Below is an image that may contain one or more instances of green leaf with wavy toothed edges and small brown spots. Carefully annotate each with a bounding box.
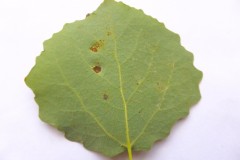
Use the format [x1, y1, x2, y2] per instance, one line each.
[26, 0, 202, 160]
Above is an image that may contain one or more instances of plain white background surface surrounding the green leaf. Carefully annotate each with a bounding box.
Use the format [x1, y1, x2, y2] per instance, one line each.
[0, 0, 240, 160]
